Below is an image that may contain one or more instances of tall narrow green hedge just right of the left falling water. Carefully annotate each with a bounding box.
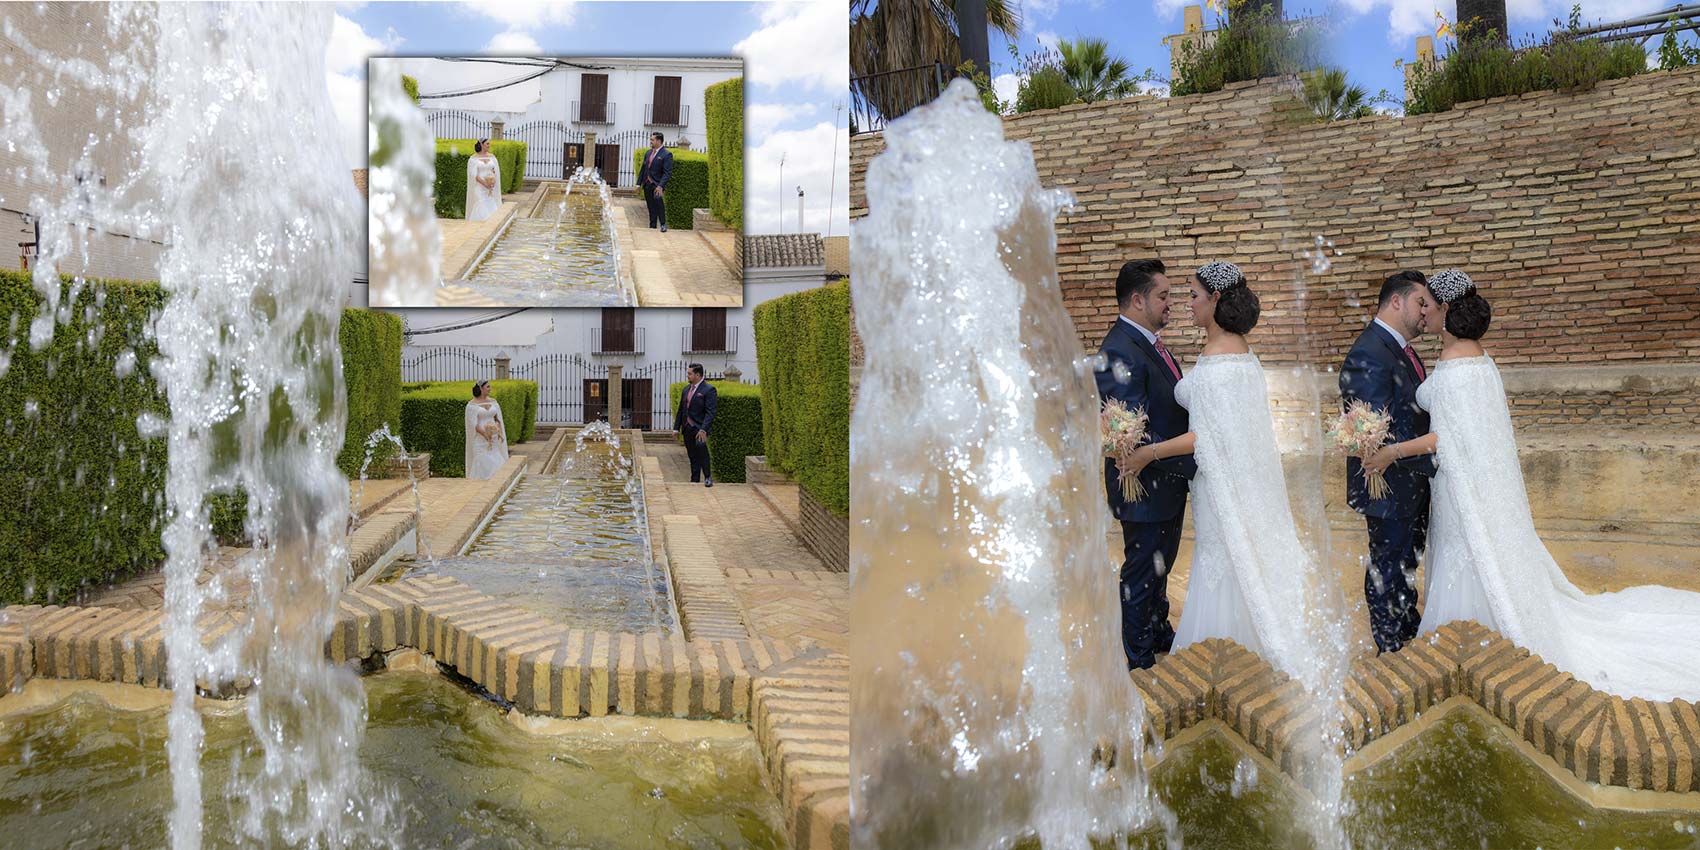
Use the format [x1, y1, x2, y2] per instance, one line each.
[337, 308, 401, 479]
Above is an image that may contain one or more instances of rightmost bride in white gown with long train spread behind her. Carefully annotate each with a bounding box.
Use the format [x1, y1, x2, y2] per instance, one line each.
[1365, 270, 1700, 700]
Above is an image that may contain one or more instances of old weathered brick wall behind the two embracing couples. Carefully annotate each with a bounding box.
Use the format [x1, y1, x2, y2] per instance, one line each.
[850, 68, 1700, 379]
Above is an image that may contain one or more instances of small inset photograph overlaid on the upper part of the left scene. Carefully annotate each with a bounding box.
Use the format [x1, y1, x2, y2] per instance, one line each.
[369, 56, 745, 308]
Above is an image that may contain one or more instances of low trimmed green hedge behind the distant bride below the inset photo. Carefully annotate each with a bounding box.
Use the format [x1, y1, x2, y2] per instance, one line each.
[401, 381, 537, 478]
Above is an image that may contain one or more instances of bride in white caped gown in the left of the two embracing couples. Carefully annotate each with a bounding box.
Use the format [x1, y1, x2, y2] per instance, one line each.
[1124, 262, 1331, 682]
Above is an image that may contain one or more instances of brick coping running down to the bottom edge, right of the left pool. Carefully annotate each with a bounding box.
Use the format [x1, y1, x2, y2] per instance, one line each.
[750, 651, 850, 850]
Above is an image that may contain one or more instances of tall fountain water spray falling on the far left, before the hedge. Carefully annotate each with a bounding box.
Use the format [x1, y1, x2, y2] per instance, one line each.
[0, 3, 397, 850]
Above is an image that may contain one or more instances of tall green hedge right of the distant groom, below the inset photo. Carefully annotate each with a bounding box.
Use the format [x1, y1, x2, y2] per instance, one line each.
[755, 282, 850, 517]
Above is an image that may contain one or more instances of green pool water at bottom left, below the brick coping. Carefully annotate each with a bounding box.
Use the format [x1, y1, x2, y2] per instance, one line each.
[0, 673, 785, 850]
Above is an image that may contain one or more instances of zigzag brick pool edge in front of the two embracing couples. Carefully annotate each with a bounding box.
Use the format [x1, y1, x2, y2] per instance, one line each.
[1132, 622, 1700, 792]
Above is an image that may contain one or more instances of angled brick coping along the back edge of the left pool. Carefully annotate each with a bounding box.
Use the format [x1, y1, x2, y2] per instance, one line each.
[0, 576, 796, 721]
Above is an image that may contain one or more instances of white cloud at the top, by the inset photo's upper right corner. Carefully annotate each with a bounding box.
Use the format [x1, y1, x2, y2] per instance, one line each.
[733, 3, 850, 92]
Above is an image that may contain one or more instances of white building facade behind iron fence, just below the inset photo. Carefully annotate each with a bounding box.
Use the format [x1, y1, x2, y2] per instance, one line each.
[394, 233, 828, 430]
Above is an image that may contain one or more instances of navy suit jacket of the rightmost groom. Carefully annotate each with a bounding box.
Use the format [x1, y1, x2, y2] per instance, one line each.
[1340, 321, 1435, 520]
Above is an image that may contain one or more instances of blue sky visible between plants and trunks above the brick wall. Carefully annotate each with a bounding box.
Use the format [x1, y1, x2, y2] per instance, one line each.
[991, 0, 1693, 111]
